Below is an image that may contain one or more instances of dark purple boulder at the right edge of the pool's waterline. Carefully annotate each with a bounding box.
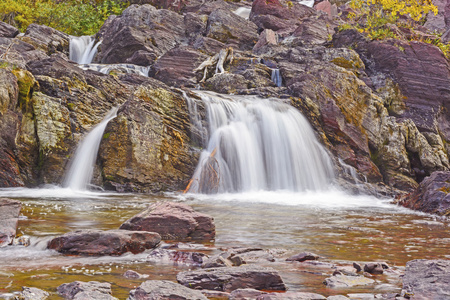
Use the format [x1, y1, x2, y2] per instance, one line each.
[399, 171, 450, 216]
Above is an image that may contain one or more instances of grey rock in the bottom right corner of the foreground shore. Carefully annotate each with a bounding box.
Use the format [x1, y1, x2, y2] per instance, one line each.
[403, 259, 450, 299]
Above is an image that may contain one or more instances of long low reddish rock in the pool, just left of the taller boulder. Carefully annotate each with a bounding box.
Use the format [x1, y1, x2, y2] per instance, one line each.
[48, 229, 161, 255]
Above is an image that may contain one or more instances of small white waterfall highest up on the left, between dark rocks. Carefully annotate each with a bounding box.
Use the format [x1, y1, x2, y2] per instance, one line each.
[69, 36, 101, 64]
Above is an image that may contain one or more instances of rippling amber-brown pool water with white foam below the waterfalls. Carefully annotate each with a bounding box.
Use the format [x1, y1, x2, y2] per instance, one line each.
[0, 190, 450, 299]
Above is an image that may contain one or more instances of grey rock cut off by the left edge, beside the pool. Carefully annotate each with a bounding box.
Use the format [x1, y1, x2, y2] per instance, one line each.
[0, 198, 22, 248]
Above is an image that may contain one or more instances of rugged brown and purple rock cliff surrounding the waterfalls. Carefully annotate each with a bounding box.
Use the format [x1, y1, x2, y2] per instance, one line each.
[0, 0, 450, 194]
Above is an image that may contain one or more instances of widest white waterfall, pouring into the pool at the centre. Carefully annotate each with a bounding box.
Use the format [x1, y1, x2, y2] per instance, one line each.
[188, 92, 334, 193]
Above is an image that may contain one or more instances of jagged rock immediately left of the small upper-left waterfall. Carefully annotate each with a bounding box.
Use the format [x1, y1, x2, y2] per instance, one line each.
[20, 23, 70, 57]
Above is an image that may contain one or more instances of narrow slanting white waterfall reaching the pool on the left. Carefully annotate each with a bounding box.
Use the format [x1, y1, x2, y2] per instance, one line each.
[63, 107, 118, 191]
